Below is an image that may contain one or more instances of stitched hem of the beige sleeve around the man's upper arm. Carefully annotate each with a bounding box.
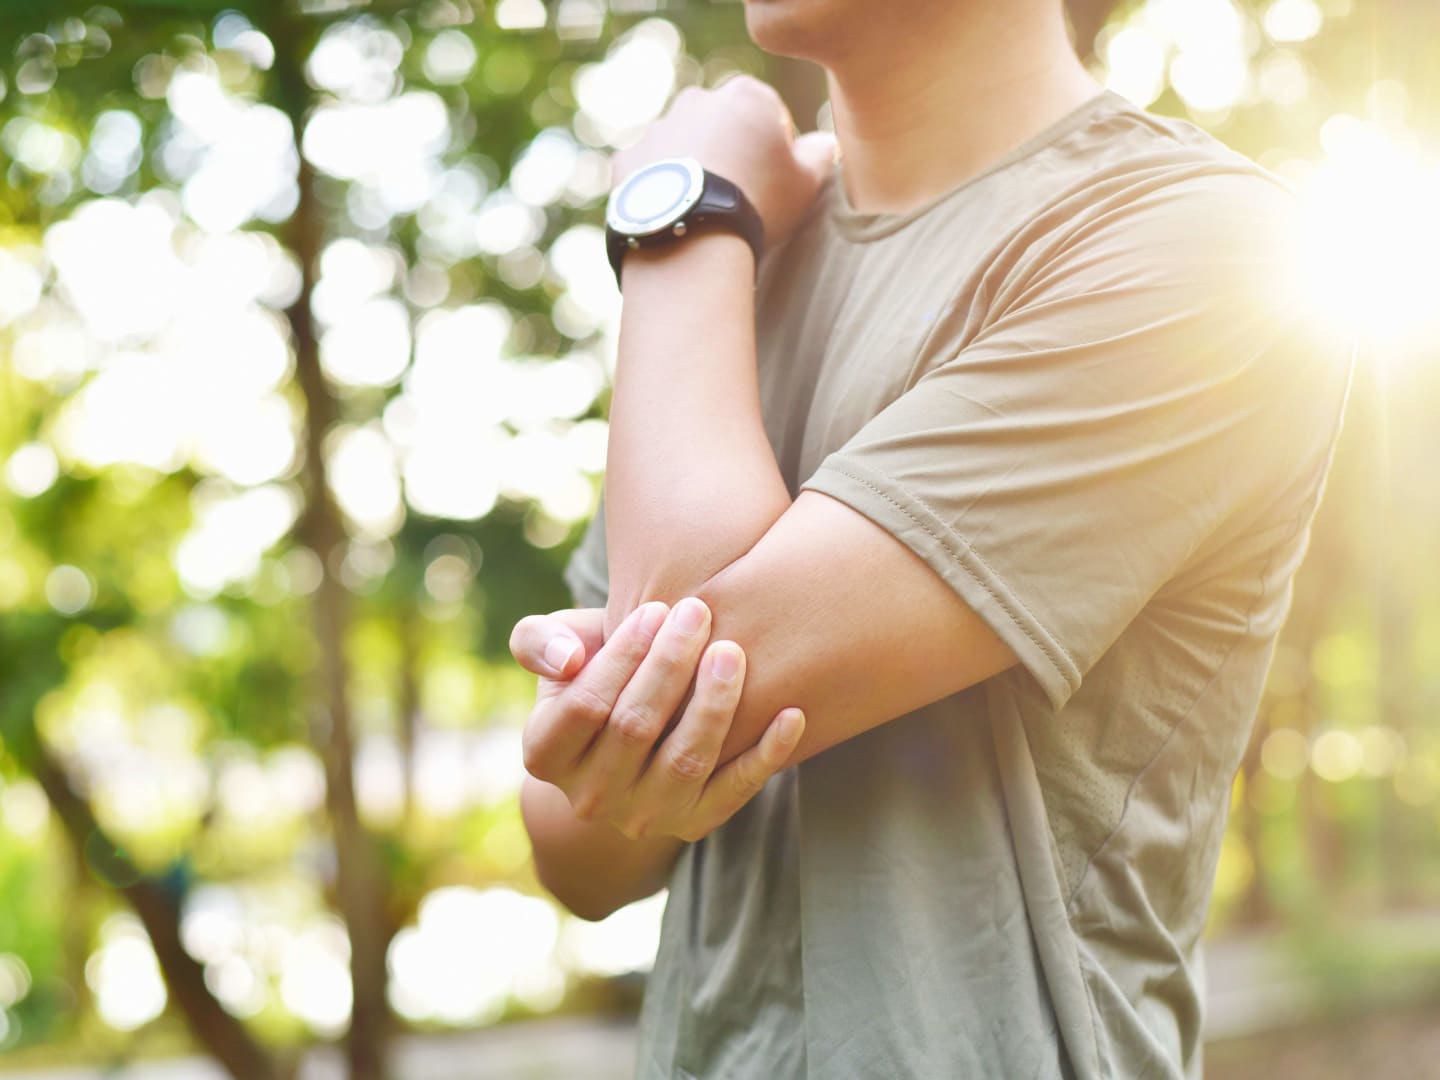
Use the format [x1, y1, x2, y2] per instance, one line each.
[801, 455, 1080, 711]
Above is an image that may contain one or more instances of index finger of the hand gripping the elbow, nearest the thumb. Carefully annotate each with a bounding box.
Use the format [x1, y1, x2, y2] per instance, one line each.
[521, 600, 668, 793]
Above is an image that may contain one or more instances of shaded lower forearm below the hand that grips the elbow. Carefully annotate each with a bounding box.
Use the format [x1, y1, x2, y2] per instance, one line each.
[520, 776, 683, 919]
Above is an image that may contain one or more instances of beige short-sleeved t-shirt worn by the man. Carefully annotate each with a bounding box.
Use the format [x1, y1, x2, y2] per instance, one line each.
[558, 94, 1349, 1080]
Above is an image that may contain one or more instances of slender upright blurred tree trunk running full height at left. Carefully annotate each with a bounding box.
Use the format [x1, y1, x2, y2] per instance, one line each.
[269, 16, 393, 1080]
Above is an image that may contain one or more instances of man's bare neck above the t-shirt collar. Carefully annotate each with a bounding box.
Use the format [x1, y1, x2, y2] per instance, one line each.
[828, 4, 1100, 213]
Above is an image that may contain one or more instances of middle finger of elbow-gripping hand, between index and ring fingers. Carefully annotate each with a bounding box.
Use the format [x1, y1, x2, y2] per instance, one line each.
[567, 596, 710, 805]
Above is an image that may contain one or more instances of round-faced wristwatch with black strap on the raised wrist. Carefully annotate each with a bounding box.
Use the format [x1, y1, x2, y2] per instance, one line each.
[605, 157, 765, 284]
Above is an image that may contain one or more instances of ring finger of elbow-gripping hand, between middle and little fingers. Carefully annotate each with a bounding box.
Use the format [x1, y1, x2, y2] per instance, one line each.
[638, 641, 744, 805]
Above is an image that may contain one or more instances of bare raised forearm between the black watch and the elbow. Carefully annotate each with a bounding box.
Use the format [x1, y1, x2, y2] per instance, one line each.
[605, 233, 791, 628]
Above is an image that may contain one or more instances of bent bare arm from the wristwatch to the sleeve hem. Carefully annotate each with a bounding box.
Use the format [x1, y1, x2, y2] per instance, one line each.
[606, 236, 1015, 762]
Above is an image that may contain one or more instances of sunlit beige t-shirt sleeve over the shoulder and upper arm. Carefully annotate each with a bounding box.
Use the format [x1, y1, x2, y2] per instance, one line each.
[802, 174, 1349, 710]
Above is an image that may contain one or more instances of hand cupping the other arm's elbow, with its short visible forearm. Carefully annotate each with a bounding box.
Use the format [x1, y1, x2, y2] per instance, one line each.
[510, 610, 805, 919]
